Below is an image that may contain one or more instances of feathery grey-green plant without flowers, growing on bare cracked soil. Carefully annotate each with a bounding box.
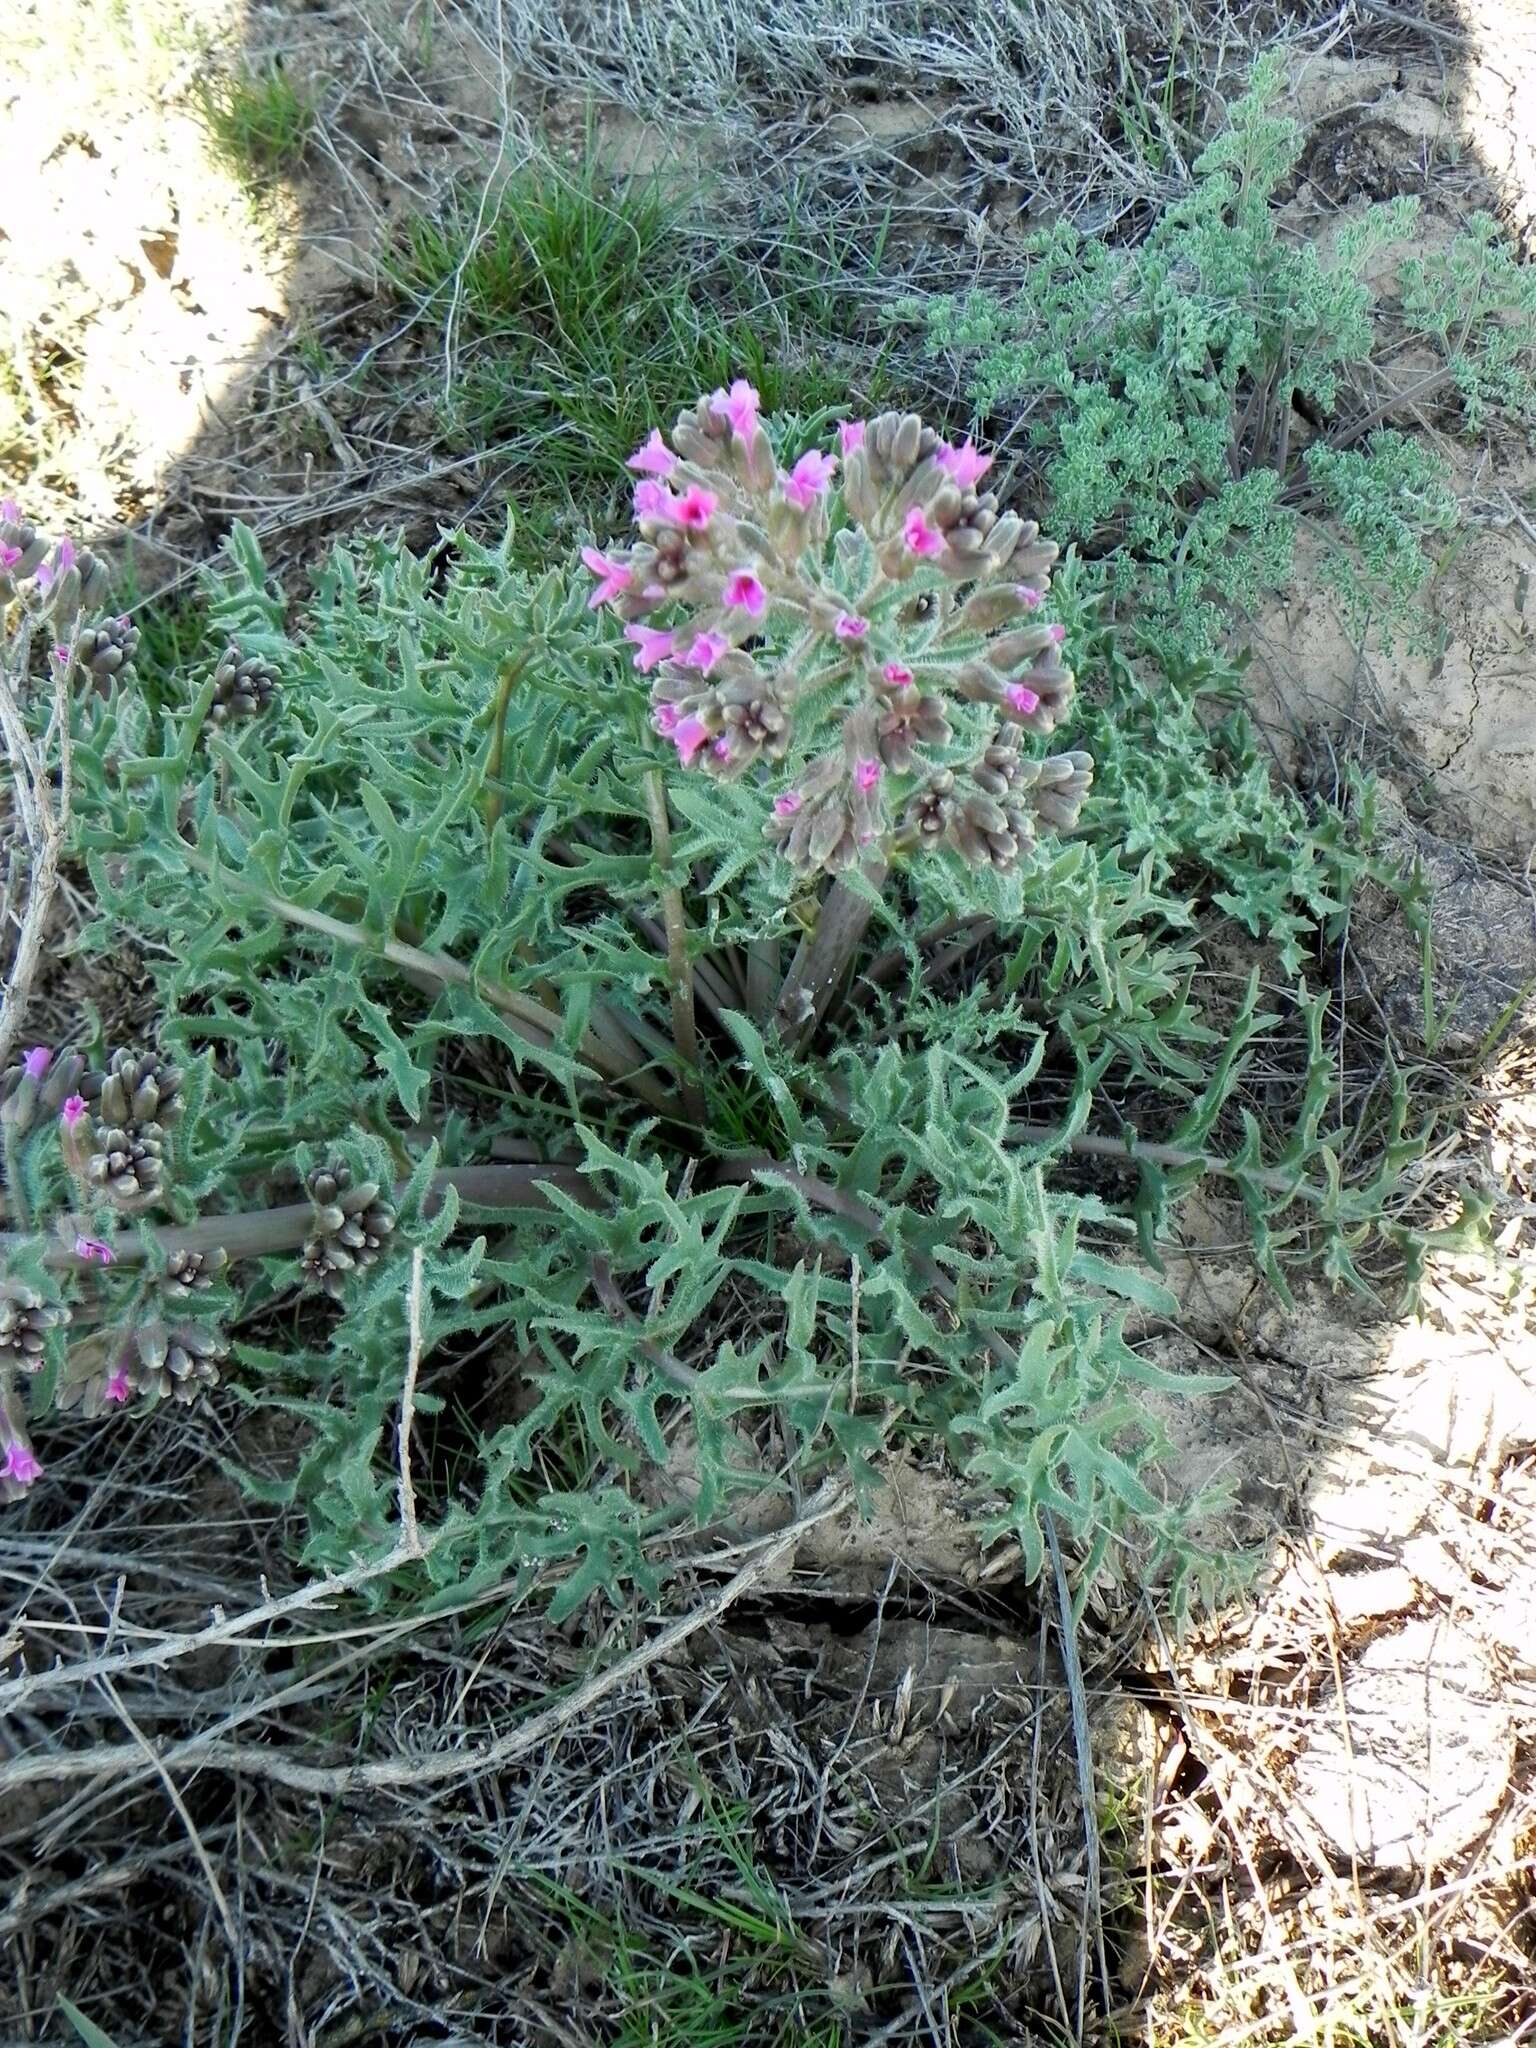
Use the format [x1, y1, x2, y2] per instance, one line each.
[907, 59, 1536, 659]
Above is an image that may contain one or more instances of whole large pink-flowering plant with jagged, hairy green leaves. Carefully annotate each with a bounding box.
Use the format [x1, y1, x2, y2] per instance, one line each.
[0, 399, 1490, 1612]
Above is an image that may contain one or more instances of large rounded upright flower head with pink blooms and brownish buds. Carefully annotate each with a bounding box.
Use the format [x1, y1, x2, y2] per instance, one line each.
[582, 379, 1094, 874]
